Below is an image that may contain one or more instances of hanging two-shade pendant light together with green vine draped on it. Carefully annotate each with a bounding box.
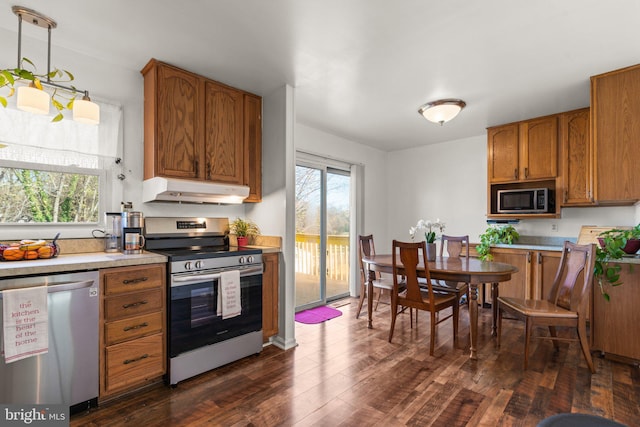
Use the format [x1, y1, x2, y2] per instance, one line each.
[0, 6, 100, 124]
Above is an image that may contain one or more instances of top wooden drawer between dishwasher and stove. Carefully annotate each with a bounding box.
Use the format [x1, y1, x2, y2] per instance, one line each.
[104, 265, 164, 295]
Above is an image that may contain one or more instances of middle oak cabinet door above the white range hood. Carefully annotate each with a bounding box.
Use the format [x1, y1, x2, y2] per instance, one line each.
[204, 81, 244, 185]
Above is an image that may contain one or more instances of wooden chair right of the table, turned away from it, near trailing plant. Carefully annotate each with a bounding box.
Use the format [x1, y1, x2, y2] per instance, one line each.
[497, 241, 596, 373]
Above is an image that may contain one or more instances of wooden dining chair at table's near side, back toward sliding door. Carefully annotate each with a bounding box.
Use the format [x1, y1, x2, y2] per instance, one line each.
[389, 240, 460, 356]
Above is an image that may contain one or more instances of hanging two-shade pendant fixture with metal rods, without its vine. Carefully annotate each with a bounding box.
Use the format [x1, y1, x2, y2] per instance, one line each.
[11, 6, 100, 124]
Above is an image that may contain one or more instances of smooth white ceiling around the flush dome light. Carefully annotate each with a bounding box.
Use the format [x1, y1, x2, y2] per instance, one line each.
[0, 0, 640, 151]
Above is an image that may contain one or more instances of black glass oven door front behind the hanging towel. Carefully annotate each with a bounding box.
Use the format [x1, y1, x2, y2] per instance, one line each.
[169, 274, 262, 357]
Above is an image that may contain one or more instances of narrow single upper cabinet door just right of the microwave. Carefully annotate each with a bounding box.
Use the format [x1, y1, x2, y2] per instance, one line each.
[557, 108, 594, 206]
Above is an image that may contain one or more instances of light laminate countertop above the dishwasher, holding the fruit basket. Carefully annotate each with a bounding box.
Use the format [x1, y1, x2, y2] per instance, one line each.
[0, 252, 167, 278]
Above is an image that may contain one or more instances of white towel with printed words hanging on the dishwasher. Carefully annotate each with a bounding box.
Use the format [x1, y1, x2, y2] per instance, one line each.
[2, 286, 49, 363]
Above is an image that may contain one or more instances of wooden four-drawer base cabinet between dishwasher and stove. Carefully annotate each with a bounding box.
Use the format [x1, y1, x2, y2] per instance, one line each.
[100, 264, 166, 400]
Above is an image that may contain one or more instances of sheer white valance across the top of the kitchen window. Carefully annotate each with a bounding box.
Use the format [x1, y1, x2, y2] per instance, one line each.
[0, 100, 122, 158]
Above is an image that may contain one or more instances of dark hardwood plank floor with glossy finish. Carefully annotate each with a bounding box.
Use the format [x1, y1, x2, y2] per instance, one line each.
[71, 299, 640, 427]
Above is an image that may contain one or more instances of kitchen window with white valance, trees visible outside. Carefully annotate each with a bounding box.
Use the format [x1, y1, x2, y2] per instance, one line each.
[0, 103, 124, 239]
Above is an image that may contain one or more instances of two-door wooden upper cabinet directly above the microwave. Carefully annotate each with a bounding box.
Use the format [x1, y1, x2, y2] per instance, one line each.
[487, 116, 558, 183]
